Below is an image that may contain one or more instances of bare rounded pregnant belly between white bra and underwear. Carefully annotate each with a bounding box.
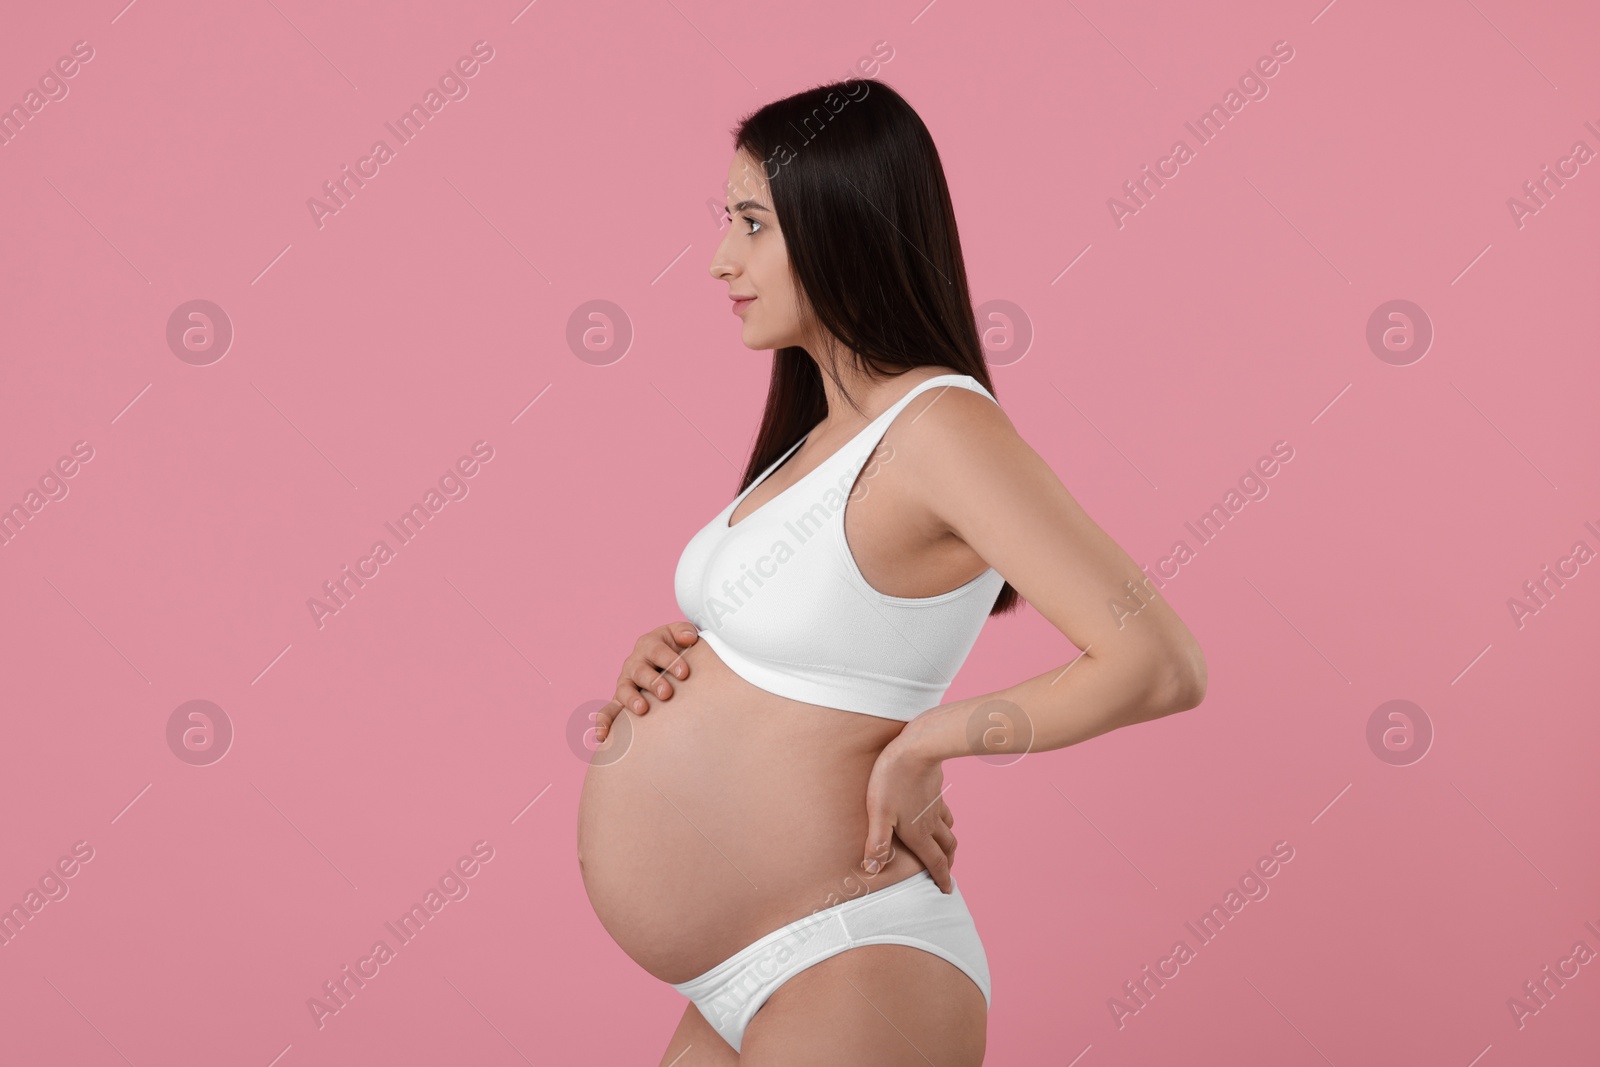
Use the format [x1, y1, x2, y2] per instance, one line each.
[578, 641, 923, 982]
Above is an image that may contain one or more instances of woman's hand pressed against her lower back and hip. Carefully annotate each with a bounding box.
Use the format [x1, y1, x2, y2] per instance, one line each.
[861, 741, 955, 893]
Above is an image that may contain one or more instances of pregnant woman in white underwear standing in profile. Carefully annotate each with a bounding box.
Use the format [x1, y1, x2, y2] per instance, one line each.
[578, 78, 1205, 1067]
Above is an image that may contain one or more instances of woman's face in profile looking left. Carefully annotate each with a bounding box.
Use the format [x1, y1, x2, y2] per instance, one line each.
[710, 152, 810, 350]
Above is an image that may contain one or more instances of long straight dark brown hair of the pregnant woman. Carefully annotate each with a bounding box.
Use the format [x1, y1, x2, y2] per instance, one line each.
[733, 78, 1019, 614]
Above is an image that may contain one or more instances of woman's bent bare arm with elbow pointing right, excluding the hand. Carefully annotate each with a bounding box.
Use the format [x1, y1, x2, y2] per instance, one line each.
[896, 389, 1206, 760]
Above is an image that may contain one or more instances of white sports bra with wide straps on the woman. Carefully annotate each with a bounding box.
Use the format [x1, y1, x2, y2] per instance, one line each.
[674, 374, 1005, 721]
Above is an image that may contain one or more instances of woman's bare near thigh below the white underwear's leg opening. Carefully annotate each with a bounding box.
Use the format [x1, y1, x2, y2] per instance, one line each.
[739, 945, 989, 1067]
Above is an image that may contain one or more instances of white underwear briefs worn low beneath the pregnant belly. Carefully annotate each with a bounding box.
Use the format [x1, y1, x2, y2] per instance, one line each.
[672, 870, 990, 1051]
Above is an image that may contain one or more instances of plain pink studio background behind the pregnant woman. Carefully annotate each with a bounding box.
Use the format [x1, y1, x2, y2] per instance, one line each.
[0, 0, 1600, 1067]
